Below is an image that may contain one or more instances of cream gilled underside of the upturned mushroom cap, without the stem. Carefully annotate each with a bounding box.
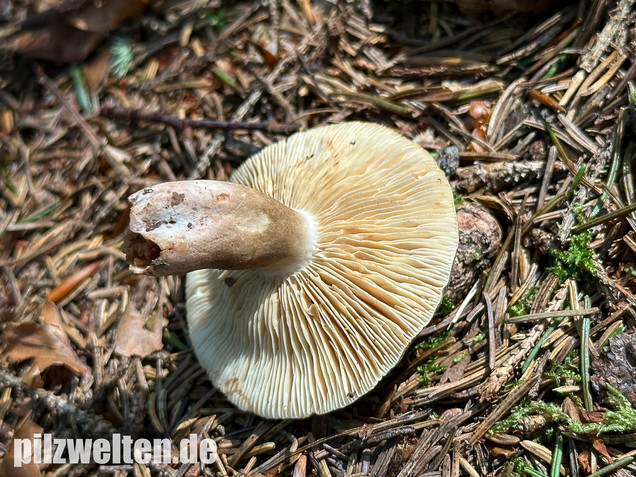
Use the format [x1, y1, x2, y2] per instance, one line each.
[186, 122, 458, 418]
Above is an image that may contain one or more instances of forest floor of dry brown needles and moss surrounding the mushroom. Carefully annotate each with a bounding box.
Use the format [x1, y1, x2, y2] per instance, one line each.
[0, 0, 636, 477]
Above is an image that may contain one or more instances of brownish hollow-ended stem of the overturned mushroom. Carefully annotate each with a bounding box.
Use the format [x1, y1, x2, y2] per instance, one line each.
[123, 180, 316, 276]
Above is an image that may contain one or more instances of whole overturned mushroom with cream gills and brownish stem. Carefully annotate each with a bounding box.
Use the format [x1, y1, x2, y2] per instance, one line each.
[124, 122, 458, 418]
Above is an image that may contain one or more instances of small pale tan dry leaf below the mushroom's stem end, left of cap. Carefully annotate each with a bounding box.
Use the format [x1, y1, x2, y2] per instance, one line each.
[115, 304, 166, 357]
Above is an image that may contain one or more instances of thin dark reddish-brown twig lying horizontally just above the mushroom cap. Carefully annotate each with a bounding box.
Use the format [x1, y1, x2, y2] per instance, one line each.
[99, 107, 298, 133]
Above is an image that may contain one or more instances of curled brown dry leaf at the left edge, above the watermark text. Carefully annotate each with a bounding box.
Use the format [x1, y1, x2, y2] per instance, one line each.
[2, 301, 89, 387]
